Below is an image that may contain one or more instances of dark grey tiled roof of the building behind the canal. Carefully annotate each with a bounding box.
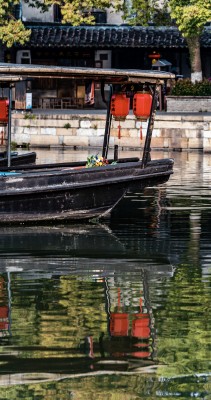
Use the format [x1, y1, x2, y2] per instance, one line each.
[26, 24, 211, 48]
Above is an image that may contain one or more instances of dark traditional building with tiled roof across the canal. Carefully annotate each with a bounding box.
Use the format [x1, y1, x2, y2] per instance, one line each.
[1, 1, 211, 107]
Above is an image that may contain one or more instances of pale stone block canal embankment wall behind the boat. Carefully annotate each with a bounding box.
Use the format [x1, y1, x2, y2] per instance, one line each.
[12, 110, 211, 152]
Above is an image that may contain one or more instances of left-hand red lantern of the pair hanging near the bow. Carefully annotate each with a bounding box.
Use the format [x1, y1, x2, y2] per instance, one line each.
[111, 93, 130, 121]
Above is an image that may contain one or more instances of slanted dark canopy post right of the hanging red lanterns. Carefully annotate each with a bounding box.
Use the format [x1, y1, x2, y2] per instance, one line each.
[142, 84, 159, 168]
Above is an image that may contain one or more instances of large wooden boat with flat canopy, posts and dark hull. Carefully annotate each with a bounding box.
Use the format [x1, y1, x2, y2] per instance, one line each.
[0, 64, 174, 224]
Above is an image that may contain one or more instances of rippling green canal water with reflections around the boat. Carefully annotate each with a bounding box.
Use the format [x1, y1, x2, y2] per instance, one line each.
[0, 150, 211, 400]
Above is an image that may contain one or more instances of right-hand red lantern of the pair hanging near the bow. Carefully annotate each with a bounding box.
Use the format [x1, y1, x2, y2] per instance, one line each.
[133, 93, 152, 121]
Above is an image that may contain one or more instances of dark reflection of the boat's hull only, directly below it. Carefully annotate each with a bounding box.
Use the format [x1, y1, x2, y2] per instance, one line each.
[0, 224, 173, 276]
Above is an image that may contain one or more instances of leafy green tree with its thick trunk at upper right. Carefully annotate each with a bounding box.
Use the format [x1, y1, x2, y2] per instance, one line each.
[120, 0, 211, 82]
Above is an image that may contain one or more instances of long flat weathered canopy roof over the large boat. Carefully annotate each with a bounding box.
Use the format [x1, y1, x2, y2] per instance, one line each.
[0, 63, 175, 84]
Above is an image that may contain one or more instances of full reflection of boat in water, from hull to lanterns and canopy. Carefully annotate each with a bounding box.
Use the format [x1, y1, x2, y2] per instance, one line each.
[0, 212, 178, 380]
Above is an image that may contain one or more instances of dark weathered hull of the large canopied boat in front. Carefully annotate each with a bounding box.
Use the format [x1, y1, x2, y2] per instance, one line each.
[0, 162, 173, 224]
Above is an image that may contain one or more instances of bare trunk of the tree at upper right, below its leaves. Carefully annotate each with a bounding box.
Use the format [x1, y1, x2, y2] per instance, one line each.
[187, 35, 202, 83]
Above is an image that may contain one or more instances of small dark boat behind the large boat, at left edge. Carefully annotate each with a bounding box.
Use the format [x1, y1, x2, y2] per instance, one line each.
[0, 151, 36, 168]
